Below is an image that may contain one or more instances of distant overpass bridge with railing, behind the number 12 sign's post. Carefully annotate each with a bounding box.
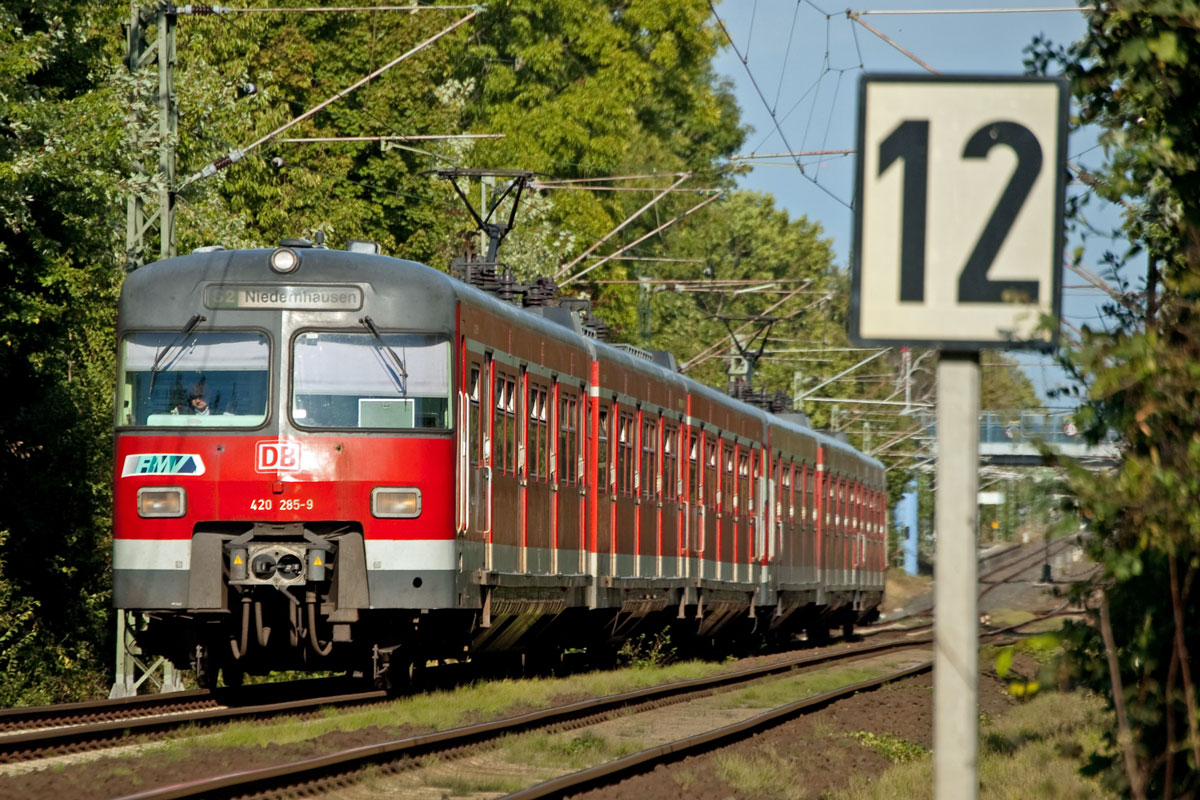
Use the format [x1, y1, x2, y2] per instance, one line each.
[926, 409, 1121, 468]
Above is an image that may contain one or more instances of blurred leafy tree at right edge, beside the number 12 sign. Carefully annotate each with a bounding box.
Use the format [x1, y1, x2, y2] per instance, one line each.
[1031, 0, 1200, 798]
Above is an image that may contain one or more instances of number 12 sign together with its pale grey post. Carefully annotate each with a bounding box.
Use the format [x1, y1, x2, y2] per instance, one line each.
[850, 74, 1067, 800]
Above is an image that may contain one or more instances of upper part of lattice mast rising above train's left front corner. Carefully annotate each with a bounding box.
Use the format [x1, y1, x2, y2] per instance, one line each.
[125, 2, 179, 270]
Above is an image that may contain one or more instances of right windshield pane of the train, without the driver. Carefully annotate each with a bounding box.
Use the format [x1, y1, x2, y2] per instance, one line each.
[292, 331, 450, 429]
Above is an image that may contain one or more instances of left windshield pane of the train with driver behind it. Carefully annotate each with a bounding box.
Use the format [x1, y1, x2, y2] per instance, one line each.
[116, 331, 271, 428]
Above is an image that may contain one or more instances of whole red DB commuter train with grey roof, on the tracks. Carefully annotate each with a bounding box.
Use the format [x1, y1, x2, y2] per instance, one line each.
[113, 240, 886, 685]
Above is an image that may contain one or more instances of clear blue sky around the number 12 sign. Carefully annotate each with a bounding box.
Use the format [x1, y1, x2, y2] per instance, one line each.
[716, 0, 1118, 404]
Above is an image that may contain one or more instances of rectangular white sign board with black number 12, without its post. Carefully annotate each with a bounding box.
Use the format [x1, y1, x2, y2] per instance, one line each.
[850, 74, 1067, 350]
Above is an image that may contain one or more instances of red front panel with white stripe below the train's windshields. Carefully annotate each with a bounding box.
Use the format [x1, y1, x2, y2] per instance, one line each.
[114, 433, 456, 609]
